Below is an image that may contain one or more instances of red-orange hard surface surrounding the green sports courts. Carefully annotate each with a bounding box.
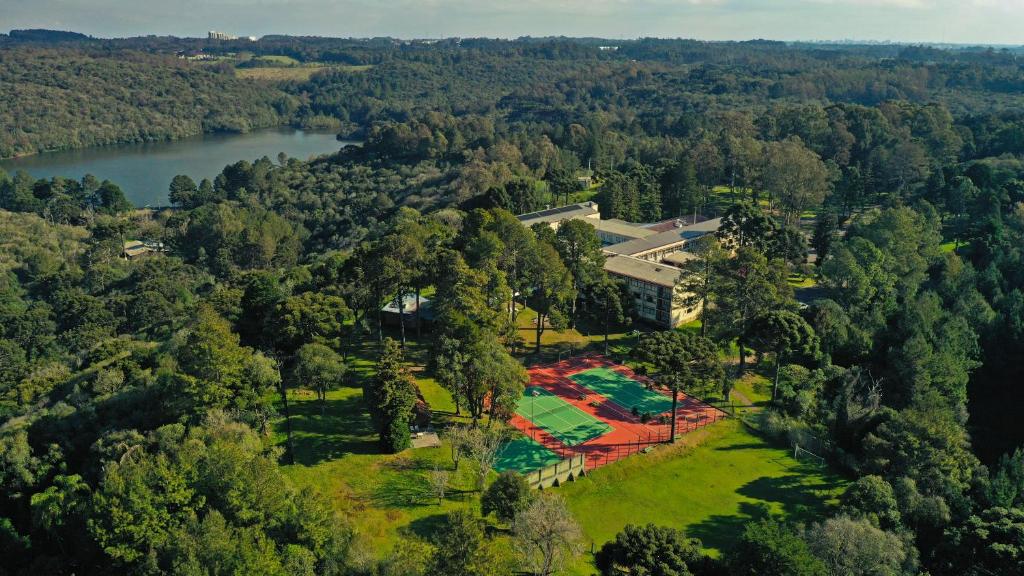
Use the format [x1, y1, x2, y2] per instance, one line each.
[510, 355, 726, 469]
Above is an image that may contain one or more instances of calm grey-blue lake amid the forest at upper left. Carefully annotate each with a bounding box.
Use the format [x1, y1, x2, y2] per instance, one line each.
[0, 128, 359, 207]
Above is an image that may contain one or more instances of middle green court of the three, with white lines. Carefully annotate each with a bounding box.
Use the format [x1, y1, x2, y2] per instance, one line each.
[515, 386, 611, 446]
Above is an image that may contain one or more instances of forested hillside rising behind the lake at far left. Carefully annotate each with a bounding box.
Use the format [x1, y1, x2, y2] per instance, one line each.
[0, 44, 298, 157]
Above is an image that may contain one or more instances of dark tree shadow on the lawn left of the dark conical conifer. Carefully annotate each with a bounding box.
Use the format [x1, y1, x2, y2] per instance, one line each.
[279, 387, 380, 466]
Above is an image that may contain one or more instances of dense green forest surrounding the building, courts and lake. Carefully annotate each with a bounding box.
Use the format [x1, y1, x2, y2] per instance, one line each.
[0, 30, 1024, 576]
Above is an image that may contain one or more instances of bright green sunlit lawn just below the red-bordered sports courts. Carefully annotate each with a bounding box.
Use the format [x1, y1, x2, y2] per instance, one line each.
[558, 420, 845, 574]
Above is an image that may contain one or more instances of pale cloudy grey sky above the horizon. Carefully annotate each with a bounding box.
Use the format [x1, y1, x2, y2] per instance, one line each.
[0, 0, 1024, 44]
